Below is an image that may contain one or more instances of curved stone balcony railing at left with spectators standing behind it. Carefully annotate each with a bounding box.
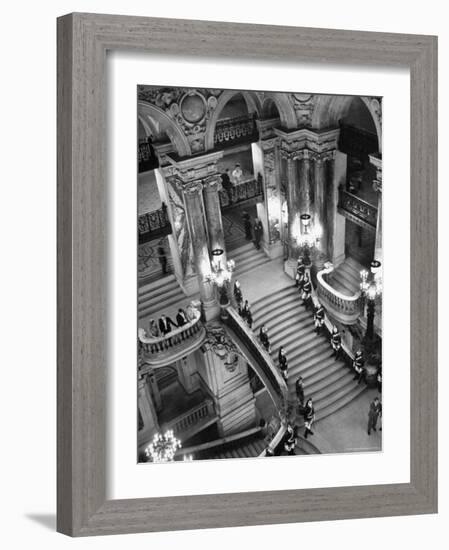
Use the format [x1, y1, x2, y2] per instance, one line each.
[138, 307, 206, 368]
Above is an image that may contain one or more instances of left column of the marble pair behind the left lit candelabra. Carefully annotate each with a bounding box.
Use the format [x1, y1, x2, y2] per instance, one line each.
[183, 181, 220, 320]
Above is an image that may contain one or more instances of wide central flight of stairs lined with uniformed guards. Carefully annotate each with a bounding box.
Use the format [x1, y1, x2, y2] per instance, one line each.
[252, 284, 364, 420]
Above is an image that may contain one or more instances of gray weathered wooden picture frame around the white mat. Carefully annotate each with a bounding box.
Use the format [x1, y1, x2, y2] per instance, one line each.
[57, 13, 437, 536]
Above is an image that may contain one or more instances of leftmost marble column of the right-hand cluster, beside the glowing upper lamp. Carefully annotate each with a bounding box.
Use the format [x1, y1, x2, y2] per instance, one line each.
[283, 151, 301, 278]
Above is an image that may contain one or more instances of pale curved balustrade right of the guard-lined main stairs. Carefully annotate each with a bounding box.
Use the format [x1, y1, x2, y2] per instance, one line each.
[317, 264, 362, 325]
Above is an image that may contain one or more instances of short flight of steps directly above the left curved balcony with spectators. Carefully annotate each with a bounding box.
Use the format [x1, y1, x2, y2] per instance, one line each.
[138, 275, 186, 319]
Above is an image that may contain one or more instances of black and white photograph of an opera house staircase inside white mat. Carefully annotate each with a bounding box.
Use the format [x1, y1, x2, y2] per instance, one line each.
[137, 85, 383, 462]
